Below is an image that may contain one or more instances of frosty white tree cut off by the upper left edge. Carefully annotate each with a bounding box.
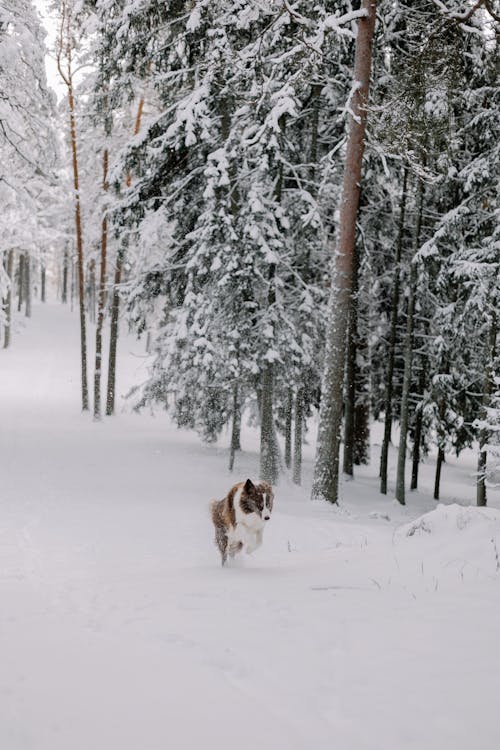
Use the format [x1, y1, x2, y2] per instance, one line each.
[0, 0, 56, 346]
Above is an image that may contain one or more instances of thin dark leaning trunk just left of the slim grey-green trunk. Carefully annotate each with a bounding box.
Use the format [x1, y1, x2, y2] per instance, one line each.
[380, 168, 408, 495]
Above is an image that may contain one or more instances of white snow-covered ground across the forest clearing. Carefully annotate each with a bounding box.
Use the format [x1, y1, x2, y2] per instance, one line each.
[0, 304, 500, 750]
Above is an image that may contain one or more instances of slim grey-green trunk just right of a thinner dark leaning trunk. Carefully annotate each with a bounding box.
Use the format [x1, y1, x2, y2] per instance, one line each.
[396, 180, 424, 505]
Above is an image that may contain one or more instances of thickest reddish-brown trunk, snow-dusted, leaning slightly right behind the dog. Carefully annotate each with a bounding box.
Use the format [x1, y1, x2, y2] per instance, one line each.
[312, 0, 377, 503]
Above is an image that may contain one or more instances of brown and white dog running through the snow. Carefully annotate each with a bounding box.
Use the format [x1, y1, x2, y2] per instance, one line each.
[210, 479, 274, 565]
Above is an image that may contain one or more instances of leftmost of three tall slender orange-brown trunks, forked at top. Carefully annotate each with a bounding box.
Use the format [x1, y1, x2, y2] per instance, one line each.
[57, 0, 89, 411]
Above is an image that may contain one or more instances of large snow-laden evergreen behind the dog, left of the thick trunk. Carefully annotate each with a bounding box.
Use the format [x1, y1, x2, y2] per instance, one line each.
[95, 2, 356, 476]
